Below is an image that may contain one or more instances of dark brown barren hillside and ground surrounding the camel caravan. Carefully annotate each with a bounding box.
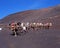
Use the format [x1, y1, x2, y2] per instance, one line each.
[0, 5, 60, 48]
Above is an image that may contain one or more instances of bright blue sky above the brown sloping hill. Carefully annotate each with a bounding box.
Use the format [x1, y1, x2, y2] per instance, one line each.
[0, 0, 60, 19]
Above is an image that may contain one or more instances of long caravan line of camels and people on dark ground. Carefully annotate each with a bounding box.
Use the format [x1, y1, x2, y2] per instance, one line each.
[9, 22, 52, 36]
